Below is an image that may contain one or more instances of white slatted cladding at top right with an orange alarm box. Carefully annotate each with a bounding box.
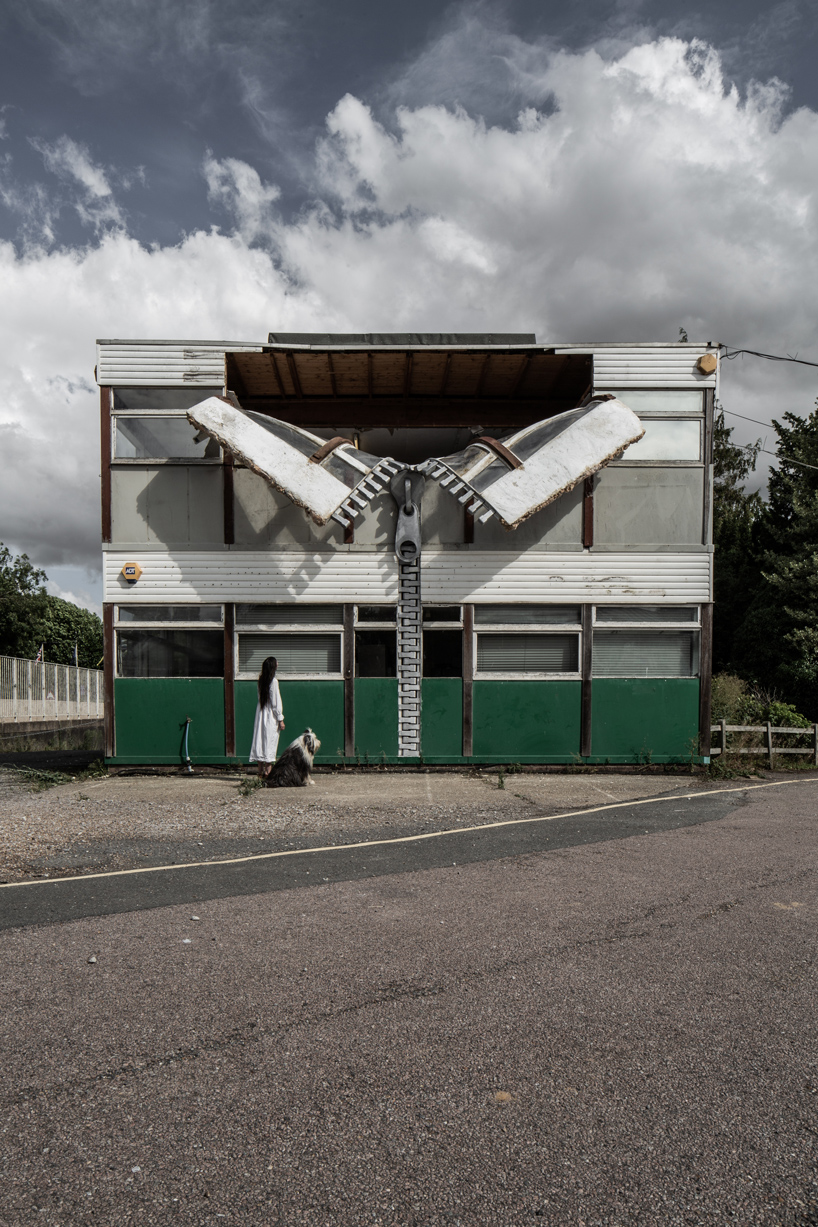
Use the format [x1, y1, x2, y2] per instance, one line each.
[557, 345, 717, 391]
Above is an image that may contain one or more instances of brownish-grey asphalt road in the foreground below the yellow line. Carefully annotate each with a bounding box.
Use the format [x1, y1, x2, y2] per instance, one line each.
[0, 779, 818, 1227]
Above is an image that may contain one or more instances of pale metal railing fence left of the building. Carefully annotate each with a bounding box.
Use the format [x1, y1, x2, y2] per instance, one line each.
[0, 656, 104, 720]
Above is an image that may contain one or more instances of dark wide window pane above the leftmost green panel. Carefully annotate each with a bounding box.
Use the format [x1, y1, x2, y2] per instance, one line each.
[117, 629, 224, 682]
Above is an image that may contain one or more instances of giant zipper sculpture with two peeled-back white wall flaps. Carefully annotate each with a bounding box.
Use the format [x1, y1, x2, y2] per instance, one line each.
[188, 395, 645, 757]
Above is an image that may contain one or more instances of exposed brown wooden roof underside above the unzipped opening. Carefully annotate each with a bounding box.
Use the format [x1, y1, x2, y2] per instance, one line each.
[226, 343, 594, 429]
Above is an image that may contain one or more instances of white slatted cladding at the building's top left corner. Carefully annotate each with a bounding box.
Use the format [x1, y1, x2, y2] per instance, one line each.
[97, 341, 261, 388]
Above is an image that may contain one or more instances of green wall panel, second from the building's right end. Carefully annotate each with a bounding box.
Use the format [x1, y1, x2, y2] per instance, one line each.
[473, 681, 583, 762]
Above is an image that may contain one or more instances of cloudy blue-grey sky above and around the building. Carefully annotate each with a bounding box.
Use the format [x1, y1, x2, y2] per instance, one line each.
[0, 0, 818, 607]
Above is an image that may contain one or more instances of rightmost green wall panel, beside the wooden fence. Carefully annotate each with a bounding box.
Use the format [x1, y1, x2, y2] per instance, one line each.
[591, 677, 699, 762]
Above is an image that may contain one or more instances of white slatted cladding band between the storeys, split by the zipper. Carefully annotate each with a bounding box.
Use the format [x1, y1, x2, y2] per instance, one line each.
[103, 548, 713, 605]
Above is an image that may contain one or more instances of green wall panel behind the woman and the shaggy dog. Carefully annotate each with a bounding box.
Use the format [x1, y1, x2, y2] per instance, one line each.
[234, 679, 343, 763]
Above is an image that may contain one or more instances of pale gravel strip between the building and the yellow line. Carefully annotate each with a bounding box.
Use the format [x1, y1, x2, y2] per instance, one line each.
[0, 769, 710, 882]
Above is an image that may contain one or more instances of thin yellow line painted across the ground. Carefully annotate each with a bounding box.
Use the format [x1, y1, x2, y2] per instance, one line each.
[0, 777, 818, 891]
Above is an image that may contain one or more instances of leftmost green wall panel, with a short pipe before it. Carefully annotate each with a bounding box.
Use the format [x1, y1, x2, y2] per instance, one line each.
[114, 677, 224, 763]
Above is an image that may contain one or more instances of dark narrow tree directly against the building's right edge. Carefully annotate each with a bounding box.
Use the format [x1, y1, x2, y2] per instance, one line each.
[713, 409, 764, 672]
